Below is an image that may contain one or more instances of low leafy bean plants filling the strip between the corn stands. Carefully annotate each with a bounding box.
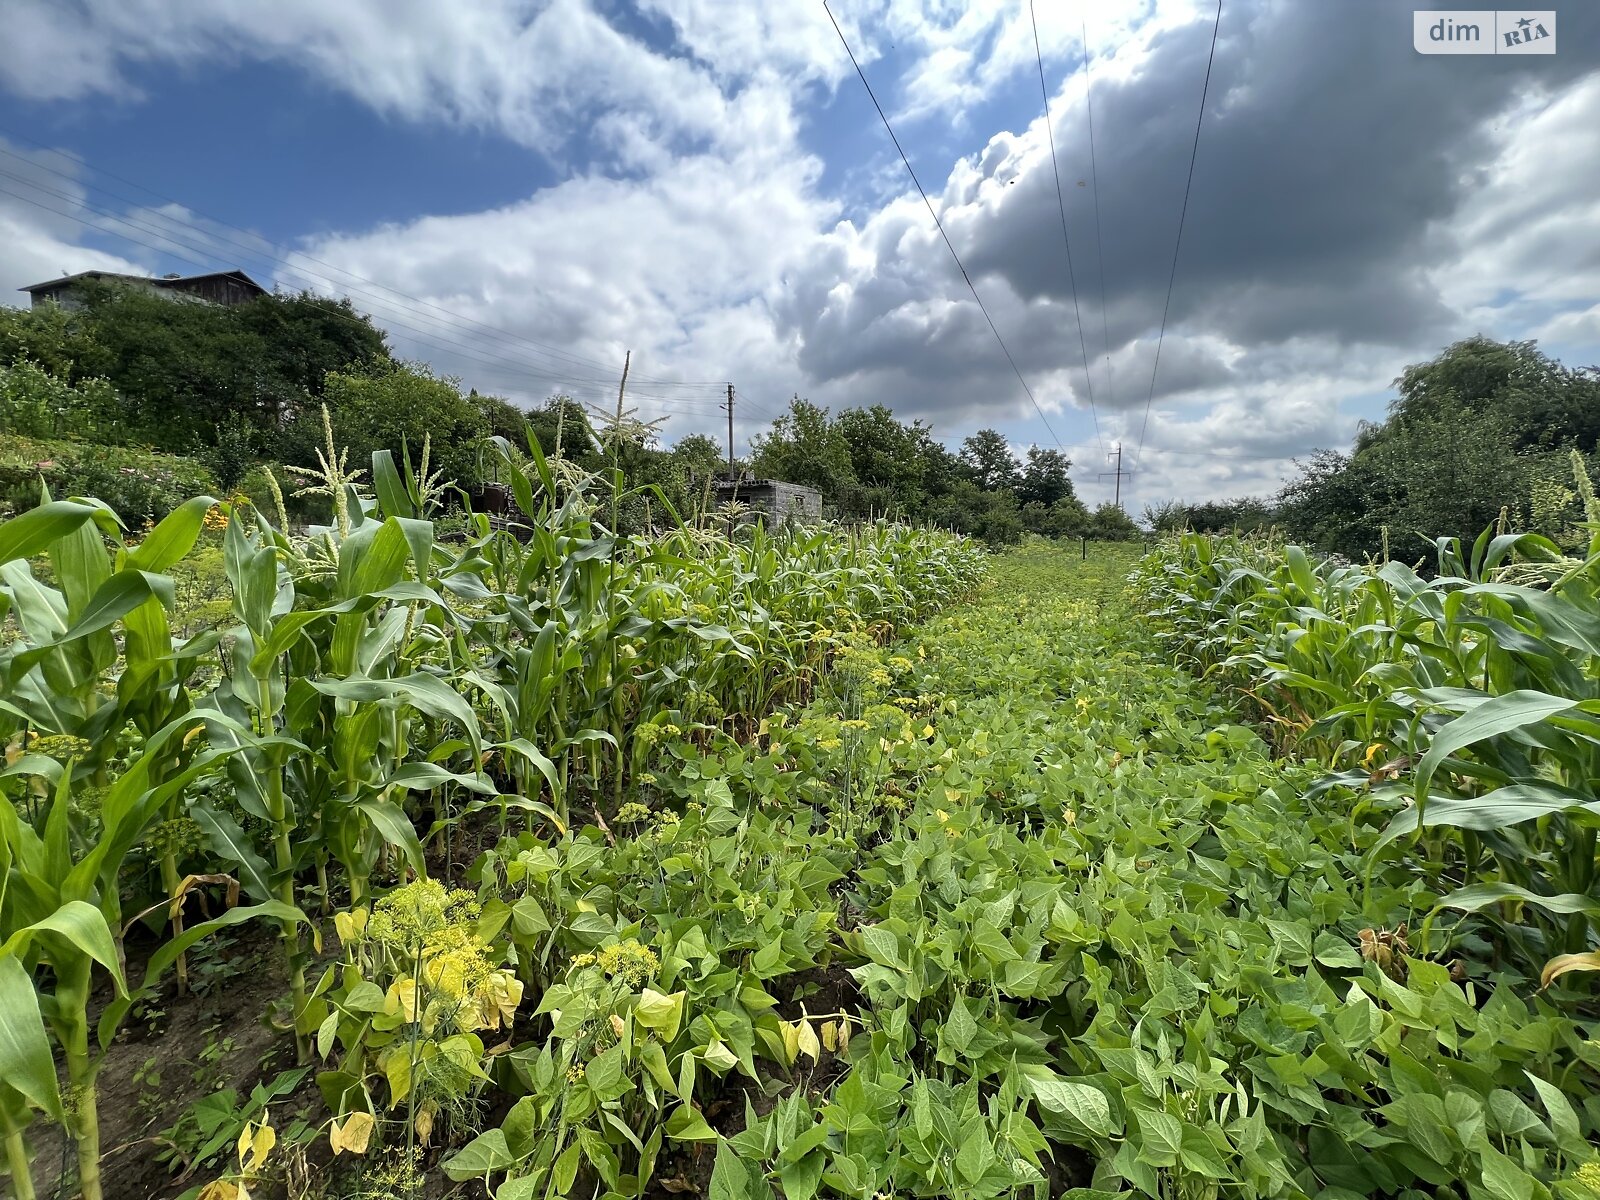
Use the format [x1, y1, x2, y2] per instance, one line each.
[445, 544, 1600, 1200]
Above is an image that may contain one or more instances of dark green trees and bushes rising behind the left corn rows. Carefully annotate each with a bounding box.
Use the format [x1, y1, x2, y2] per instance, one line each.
[0, 283, 1138, 544]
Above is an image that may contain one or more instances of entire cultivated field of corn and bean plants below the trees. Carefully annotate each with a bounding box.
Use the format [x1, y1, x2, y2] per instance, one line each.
[0, 478, 1600, 1200]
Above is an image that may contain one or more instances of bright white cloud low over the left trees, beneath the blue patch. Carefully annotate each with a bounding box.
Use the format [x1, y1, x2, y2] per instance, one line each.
[284, 135, 829, 448]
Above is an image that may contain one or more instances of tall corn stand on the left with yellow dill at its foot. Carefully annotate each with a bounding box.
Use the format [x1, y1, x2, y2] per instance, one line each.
[0, 445, 981, 1200]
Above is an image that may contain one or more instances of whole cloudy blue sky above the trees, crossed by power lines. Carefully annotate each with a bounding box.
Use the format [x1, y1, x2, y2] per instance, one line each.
[0, 0, 1600, 506]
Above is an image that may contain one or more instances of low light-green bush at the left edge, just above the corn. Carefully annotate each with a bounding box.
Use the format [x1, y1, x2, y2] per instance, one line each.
[0, 434, 218, 530]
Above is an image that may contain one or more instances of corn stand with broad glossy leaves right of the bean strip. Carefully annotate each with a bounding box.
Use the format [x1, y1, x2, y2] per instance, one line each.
[1141, 530, 1600, 976]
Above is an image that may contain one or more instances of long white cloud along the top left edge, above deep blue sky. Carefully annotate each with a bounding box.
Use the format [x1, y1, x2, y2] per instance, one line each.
[0, 0, 780, 168]
